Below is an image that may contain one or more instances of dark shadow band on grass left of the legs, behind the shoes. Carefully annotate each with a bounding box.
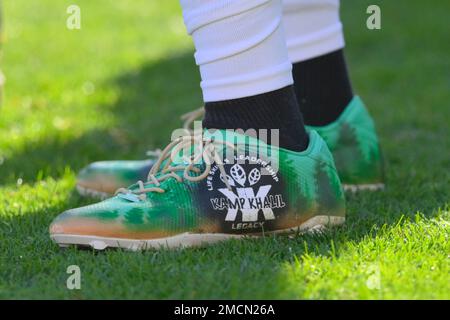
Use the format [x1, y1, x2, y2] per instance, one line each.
[0, 52, 201, 184]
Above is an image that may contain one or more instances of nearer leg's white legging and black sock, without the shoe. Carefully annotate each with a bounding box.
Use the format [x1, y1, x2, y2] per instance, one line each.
[181, 0, 308, 151]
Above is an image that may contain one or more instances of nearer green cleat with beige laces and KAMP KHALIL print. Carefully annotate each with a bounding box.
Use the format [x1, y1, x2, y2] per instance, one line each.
[50, 130, 345, 250]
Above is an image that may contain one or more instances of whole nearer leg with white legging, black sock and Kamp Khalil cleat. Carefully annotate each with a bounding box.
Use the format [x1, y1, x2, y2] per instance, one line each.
[50, 0, 345, 249]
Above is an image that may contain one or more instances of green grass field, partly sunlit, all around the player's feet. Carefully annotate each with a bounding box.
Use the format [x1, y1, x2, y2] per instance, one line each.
[0, 0, 450, 299]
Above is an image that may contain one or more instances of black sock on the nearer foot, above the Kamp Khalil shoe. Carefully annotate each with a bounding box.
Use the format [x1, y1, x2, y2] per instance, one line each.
[203, 85, 309, 151]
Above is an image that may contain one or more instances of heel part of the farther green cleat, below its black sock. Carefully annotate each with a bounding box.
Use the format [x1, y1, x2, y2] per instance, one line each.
[307, 96, 384, 191]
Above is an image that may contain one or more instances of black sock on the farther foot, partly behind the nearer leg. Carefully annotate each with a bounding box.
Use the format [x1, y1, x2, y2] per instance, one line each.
[292, 50, 353, 126]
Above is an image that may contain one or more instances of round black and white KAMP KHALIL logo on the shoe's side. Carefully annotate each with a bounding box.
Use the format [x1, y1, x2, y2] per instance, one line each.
[205, 156, 286, 233]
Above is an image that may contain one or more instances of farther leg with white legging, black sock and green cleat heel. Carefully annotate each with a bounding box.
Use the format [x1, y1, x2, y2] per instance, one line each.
[283, 0, 383, 188]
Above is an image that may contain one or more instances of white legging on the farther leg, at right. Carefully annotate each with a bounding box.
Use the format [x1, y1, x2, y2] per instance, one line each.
[283, 0, 344, 63]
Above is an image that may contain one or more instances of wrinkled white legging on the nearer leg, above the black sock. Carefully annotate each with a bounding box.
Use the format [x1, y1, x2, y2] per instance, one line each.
[180, 0, 293, 102]
